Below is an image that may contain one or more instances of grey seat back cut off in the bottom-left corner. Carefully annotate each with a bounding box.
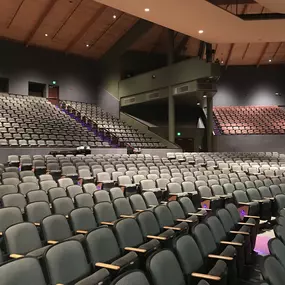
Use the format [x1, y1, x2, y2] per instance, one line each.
[0, 257, 47, 285]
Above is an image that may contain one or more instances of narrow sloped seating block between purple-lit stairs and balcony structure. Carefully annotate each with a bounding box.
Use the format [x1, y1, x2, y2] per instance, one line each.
[61, 101, 165, 148]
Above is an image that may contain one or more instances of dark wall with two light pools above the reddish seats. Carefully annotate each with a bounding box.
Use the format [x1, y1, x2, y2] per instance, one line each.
[214, 65, 285, 106]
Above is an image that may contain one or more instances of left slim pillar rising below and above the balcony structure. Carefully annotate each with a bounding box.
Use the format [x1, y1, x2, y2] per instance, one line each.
[168, 30, 175, 143]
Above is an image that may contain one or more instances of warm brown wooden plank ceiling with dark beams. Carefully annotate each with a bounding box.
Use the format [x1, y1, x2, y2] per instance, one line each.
[0, 0, 285, 66]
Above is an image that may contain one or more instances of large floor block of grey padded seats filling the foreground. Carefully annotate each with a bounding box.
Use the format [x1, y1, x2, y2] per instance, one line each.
[0, 153, 285, 285]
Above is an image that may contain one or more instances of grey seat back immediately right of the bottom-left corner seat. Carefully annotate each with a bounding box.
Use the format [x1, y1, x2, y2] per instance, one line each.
[44, 240, 90, 284]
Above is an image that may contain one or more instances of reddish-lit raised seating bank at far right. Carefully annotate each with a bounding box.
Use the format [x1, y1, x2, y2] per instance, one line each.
[213, 106, 285, 135]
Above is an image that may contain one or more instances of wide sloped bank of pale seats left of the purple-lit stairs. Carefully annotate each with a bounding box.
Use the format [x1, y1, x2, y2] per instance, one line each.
[0, 94, 110, 147]
